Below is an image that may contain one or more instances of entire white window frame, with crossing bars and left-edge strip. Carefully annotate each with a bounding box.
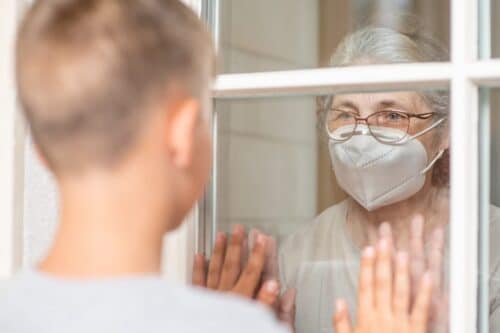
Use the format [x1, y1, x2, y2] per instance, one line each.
[0, 0, 492, 333]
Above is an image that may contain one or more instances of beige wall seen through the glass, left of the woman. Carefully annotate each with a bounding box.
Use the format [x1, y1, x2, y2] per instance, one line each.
[217, 0, 319, 241]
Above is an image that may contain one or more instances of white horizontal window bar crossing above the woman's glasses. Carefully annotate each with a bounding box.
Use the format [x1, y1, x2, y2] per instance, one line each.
[213, 63, 452, 98]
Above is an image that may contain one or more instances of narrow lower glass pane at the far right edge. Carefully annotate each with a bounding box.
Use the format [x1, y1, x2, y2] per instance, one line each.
[479, 89, 500, 332]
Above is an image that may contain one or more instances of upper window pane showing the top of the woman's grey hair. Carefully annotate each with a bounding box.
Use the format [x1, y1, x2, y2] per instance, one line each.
[219, 0, 449, 73]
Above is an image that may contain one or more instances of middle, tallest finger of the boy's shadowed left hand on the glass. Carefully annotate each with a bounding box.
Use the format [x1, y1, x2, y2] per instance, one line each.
[219, 224, 245, 290]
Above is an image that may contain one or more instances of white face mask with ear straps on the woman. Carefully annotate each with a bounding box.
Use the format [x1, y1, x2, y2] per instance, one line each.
[328, 119, 444, 211]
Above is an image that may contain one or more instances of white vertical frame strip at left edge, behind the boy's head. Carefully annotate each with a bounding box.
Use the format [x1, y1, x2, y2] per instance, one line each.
[0, 0, 26, 278]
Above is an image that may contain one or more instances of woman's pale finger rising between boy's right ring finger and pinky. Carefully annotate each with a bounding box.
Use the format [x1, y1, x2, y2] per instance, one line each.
[410, 215, 425, 296]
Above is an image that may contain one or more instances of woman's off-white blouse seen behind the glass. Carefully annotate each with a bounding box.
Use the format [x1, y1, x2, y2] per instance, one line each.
[279, 199, 500, 333]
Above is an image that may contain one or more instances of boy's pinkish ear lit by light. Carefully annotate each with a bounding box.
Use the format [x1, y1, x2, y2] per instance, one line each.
[166, 98, 200, 169]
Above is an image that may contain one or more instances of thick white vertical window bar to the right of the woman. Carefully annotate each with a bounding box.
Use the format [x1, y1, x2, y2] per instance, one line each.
[450, 0, 479, 333]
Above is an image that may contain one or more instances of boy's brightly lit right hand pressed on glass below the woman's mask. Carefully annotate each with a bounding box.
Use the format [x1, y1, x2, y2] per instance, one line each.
[333, 238, 432, 333]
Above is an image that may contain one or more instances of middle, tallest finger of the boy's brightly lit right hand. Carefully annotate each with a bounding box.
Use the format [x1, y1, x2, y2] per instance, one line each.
[375, 239, 392, 314]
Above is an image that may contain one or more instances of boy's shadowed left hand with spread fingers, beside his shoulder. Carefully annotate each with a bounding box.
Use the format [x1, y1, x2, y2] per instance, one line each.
[193, 225, 280, 306]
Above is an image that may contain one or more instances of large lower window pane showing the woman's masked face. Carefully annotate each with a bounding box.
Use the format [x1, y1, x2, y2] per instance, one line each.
[216, 91, 449, 333]
